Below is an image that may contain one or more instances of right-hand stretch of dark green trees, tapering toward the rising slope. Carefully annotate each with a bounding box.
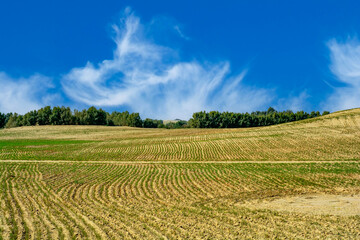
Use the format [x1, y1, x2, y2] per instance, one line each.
[188, 107, 329, 128]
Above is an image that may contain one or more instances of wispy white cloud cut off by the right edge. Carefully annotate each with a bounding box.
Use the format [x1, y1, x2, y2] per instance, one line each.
[325, 39, 360, 111]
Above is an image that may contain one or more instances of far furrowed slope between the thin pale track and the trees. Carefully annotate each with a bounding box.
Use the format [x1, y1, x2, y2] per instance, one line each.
[0, 109, 360, 161]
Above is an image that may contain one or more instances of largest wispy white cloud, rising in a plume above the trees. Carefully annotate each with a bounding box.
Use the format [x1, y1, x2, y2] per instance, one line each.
[62, 9, 272, 119]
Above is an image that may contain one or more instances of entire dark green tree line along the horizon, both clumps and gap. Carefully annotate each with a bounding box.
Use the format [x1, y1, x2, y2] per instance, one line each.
[0, 106, 329, 128]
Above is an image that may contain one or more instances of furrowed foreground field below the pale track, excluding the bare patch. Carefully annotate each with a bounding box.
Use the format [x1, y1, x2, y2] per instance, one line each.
[0, 163, 360, 239]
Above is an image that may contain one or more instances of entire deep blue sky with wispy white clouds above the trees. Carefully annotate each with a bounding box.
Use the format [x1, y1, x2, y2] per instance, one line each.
[0, 0, 360, 119]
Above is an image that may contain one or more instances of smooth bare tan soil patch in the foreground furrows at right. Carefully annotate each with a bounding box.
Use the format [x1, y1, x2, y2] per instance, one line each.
[240, 194, 360, 216]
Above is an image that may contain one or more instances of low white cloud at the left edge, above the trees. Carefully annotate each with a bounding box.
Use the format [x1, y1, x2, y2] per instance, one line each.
[0, 72, 55, 114]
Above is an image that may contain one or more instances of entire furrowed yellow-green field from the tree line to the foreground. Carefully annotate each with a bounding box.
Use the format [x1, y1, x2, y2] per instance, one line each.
[0, 109, 360, 239]
